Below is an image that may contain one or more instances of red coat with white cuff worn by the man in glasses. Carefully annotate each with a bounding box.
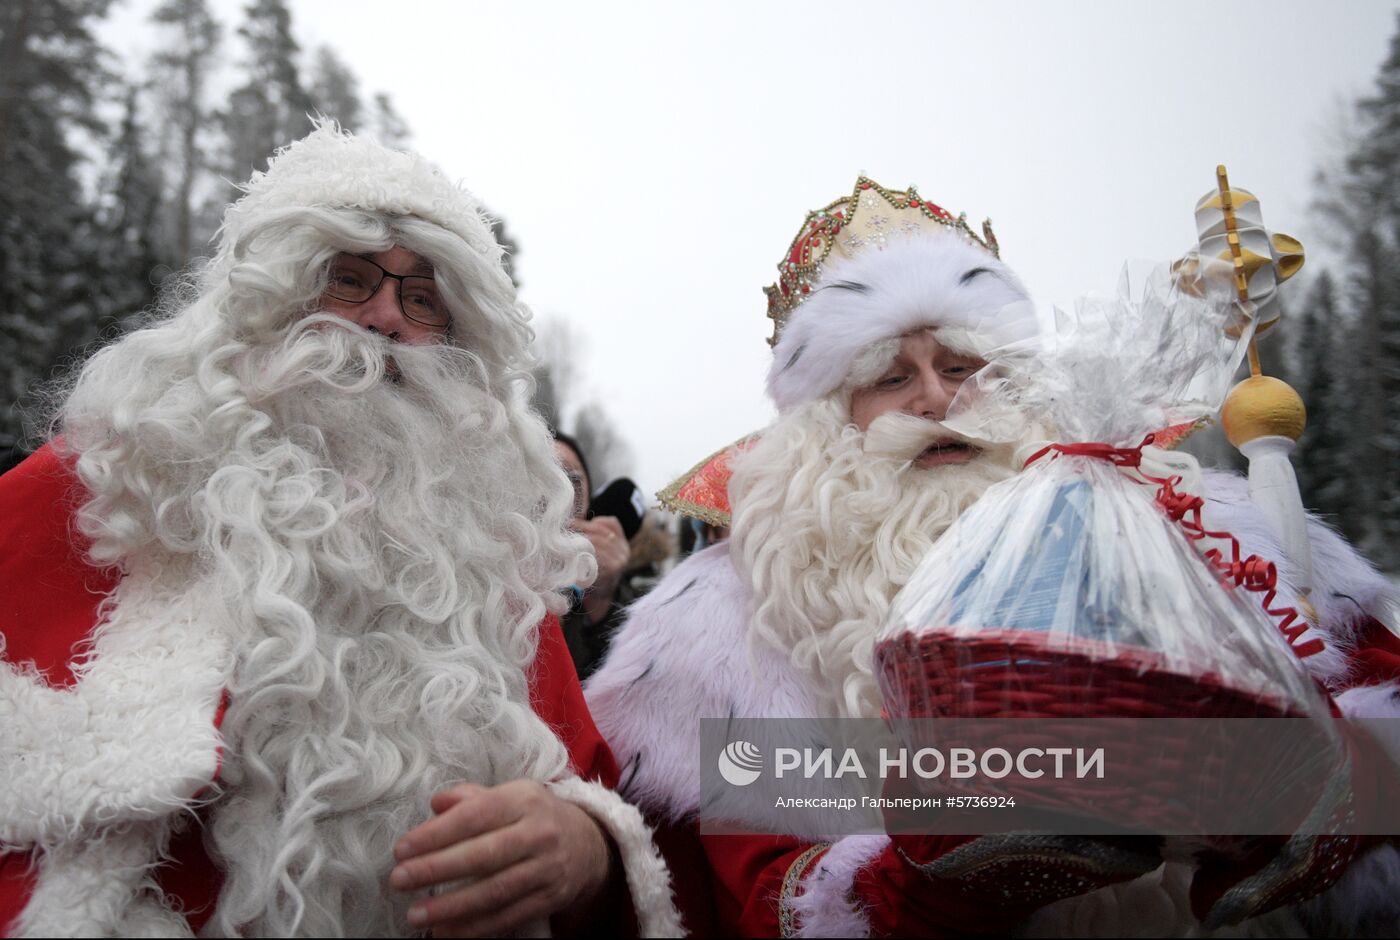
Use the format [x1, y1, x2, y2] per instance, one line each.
[0, 447, 679, 936]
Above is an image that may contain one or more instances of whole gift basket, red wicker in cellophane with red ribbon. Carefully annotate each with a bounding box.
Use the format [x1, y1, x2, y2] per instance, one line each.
[875, 259, 1344, 832]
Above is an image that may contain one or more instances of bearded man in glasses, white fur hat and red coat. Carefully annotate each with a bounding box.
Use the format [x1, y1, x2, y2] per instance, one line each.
[0, 126, 678, 936]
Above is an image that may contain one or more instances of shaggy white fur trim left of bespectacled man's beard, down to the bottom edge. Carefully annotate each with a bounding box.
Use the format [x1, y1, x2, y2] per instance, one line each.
[0, 568, 231, 936]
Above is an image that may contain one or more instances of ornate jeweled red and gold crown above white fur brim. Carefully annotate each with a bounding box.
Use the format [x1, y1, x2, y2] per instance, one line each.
[763, 177, 1001, 346]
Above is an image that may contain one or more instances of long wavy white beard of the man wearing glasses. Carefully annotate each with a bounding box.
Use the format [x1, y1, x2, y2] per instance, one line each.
[64, 318, 592, 936]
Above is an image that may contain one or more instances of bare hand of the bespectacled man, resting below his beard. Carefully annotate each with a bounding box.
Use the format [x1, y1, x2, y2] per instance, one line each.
[389, 780, 612, 937]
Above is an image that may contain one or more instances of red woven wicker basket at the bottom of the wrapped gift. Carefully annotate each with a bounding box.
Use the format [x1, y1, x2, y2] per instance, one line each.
[875, 630, 1324, 832]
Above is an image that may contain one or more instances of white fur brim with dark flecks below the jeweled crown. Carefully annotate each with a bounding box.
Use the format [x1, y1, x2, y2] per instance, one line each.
[769, 233, 1036, 413]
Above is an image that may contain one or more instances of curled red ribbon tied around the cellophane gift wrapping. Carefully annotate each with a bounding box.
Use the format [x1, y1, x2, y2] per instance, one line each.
[1023, 434, 1326, 660]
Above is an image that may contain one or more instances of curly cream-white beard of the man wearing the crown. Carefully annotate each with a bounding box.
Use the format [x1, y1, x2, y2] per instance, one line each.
[729, 396, 1014, 717]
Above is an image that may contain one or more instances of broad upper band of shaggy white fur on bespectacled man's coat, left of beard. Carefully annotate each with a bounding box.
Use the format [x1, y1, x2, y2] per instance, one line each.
[0, 579, 231, 848]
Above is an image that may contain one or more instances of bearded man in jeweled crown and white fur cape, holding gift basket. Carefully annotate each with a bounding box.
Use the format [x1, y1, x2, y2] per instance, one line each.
[587, 179, 1400, 937]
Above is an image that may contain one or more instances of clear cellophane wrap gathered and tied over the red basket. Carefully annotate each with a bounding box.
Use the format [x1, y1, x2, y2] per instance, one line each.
[875, 264, 1331, 829]
